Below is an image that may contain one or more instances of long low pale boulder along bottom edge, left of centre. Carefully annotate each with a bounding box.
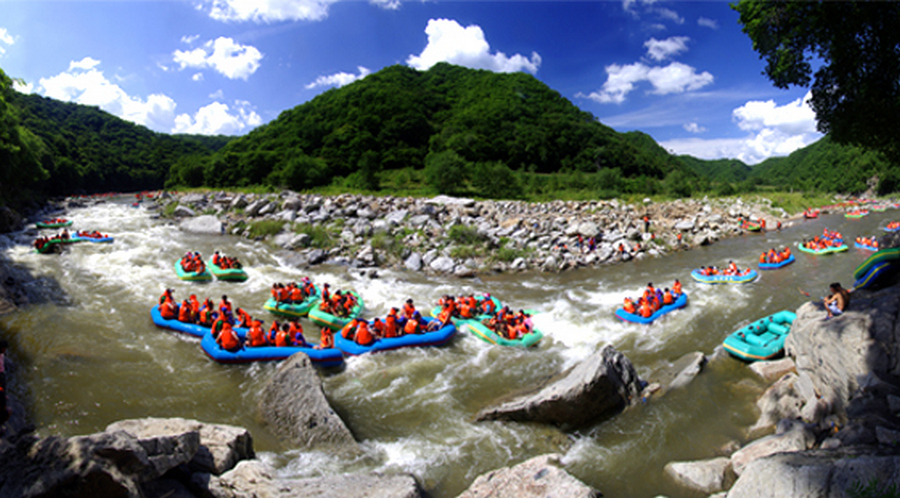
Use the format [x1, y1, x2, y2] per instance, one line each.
[192, 460, 423, 498]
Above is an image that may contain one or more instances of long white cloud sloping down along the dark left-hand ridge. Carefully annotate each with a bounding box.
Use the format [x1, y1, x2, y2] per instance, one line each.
[36, 57, 175, 131]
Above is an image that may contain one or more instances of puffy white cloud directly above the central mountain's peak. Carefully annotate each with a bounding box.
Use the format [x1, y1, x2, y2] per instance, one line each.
[406, 19, 541, 74]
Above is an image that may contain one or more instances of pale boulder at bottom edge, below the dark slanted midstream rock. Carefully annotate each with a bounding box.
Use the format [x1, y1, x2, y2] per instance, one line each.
[458, 454, 603, 498]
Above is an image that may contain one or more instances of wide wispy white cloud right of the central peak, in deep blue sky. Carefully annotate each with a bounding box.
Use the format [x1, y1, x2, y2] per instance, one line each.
[577, 62, 714, 104]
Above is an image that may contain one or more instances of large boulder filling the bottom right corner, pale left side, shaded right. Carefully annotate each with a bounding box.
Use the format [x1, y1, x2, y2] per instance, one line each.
[728, 447, 900, 498]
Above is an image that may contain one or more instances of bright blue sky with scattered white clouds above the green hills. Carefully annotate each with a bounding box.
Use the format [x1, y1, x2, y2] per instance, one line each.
[0, 0, 821, 164]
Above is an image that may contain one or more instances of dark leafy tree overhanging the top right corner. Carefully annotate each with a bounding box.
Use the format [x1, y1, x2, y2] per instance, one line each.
[733, 0, 900, 163]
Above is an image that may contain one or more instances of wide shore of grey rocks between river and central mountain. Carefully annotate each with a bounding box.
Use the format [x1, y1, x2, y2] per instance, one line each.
[146, 191, 788, 277]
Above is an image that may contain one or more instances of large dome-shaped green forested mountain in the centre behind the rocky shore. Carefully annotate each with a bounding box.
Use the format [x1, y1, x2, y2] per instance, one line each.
[169, 63, 696, 193]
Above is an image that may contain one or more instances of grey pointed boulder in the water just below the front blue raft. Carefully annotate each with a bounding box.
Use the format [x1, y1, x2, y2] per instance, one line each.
[259, 353, 359, 453]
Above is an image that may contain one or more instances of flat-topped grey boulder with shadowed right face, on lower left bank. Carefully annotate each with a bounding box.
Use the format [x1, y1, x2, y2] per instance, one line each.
[106, 418, 255, 475]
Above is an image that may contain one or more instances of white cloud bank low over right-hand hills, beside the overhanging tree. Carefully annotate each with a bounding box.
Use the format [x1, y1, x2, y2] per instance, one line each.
[660, 93, 822, 164]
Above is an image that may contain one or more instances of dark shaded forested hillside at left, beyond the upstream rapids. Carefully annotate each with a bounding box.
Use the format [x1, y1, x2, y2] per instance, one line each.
[9, 92, 230, 194]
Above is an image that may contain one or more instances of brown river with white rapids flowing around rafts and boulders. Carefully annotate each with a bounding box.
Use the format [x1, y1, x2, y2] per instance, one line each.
[0, 198, 884, 498]
